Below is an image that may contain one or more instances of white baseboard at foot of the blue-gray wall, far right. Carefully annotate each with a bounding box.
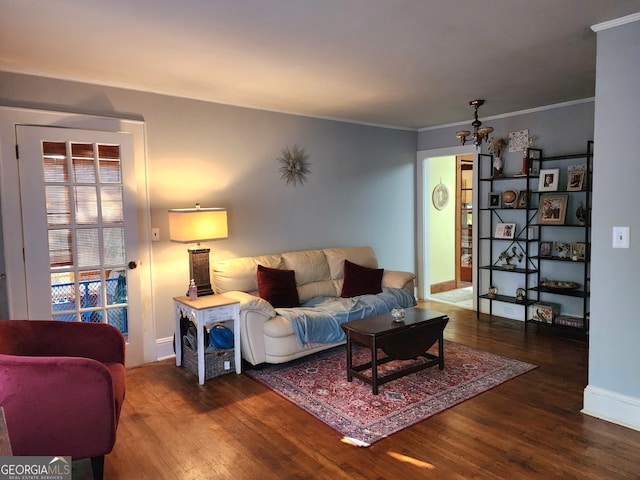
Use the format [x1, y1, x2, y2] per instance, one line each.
[582, 385, 640, 431]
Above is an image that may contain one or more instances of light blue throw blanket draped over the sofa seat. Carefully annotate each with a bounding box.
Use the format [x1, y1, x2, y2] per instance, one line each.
[276, 288, 416, 345]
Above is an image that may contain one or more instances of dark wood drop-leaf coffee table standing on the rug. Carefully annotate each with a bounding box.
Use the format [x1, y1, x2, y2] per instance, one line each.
[342, 308, 449, 395]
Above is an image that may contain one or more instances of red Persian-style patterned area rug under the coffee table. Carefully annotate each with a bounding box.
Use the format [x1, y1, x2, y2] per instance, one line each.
[244, 340, 536, 447]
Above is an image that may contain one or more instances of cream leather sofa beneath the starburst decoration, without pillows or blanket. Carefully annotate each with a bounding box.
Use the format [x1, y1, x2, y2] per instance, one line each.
[211, 247, 415, 365]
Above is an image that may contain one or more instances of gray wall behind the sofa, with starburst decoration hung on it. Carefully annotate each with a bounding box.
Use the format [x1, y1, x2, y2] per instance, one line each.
[0, 72, 417, 338]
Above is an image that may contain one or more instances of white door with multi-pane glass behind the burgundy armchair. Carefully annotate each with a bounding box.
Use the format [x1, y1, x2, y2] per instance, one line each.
[16, 126, 143, 364]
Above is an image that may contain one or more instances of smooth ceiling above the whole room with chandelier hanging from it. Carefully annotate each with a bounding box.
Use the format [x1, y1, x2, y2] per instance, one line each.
[0, 0, 640, 129]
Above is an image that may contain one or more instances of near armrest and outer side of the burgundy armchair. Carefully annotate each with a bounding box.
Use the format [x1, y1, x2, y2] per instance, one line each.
[0, 354, 117, 458]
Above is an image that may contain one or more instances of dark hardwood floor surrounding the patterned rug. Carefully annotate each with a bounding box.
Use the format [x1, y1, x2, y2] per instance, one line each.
[79, 302, 640, 480]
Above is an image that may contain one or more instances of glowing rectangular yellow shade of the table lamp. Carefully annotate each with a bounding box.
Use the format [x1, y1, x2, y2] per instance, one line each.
[169, 207, 229, 243]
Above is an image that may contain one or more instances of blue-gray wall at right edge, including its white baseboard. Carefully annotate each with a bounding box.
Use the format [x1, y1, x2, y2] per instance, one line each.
[585, 17, 640, 429]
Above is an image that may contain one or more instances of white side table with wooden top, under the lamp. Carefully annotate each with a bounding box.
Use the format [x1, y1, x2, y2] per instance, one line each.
[173, 294, 242, 385]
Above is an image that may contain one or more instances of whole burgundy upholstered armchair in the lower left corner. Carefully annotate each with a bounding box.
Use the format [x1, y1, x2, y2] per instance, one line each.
[0, 320, 125, 480]
